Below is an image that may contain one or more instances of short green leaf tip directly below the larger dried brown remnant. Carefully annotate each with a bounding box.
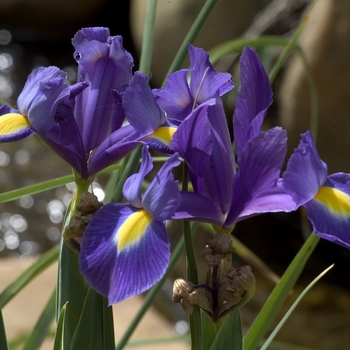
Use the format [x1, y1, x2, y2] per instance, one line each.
[210, 309, 243, 350]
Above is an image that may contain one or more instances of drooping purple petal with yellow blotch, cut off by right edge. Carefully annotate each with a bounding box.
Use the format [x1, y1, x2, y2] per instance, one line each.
[305, 173, 350, 249]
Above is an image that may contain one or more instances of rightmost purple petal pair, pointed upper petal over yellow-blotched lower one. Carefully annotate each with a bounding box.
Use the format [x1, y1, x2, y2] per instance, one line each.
[283, 132, 350, 249]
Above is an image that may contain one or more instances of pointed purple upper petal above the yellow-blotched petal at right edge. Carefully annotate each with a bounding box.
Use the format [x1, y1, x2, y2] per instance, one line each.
[283, 131, 327, 205]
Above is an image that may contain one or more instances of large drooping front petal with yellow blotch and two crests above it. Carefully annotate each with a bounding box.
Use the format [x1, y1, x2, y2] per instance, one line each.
[79, 145, 180, 304]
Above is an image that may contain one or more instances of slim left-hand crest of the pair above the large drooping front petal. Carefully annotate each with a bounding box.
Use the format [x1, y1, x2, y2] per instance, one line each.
[123, 145, 153, 208]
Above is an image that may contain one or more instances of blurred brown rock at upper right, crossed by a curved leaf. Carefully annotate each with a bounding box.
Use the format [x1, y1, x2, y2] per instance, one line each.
[276, 0, 350, 173]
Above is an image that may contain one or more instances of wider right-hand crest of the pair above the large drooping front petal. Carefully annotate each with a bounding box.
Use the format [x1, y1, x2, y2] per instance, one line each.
[142, 153, 180, 222]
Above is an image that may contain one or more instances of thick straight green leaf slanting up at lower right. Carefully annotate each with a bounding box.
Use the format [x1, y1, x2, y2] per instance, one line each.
[244, 233, 320, 350]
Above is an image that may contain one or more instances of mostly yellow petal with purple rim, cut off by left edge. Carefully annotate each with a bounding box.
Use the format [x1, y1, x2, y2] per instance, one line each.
[0, 113, 34, 142]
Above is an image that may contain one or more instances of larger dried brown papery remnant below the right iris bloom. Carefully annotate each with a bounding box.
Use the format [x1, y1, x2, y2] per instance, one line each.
[173, 232, 255, 322]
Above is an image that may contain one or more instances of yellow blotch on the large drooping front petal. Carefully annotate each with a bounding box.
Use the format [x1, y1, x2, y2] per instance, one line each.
[116, 209, 152, 250]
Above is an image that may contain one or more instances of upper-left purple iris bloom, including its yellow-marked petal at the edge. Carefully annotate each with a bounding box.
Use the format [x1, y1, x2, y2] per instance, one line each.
[0, 28, 140, 179]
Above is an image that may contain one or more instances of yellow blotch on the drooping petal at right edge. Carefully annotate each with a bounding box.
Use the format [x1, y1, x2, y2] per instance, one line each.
[314, 187, 350, 215]
